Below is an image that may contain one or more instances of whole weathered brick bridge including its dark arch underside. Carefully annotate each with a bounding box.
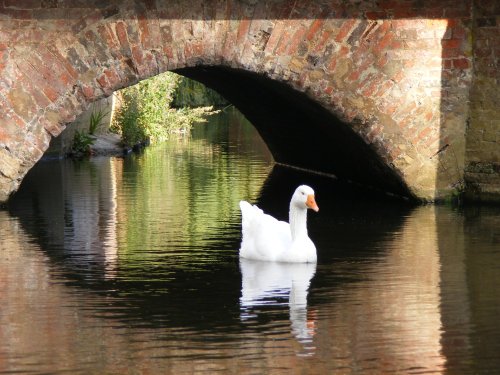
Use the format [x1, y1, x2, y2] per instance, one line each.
[0, 0, 500, 202]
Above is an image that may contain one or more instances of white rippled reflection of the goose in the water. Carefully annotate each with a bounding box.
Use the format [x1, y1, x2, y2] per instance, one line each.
[240, 259, 316, 355]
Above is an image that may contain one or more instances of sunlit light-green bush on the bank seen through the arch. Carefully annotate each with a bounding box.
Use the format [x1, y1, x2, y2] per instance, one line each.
[114, 72, 218, 146]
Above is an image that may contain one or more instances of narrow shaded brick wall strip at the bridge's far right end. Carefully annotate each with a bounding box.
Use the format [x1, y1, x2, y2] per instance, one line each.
[465, 0, 500, 201]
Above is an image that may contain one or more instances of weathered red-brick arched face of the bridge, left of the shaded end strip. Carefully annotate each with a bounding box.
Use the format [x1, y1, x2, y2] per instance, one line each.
[0, 0, 498, 201]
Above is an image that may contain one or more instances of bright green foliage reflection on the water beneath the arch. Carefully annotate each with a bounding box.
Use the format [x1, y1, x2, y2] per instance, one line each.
[118, 110, 270, 265]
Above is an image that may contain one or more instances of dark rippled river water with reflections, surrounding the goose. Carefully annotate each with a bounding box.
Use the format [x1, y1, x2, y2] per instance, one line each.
[0, 111, 500, 374]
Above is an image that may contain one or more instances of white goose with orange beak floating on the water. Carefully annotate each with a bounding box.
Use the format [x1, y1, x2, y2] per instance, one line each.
[240, 185, 319, 263]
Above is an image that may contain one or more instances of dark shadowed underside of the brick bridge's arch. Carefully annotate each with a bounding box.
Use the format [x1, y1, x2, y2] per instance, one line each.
[175, 66, 411, 197]
